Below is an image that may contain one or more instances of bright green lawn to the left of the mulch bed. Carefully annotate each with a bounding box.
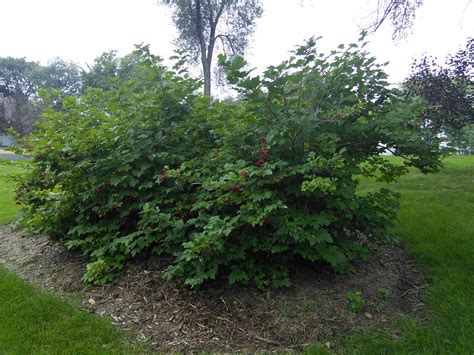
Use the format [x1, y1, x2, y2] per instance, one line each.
[0, 161, 146, 354]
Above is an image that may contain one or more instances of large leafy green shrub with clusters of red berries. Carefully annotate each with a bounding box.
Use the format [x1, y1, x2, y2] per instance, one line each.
[17, 40, 439, 288]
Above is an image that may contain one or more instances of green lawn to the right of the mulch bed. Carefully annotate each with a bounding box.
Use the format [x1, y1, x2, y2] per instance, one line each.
[314, 156, 474, 354]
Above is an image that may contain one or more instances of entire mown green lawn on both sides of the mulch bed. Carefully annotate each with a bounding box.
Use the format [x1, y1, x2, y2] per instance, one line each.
[0, 157, 474, 354]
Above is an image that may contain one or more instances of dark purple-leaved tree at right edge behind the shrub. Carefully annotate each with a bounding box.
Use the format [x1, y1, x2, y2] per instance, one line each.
[404, 38, 474, 145]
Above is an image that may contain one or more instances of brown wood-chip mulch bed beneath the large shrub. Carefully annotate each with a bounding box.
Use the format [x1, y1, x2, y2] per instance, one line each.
[0, 226, 425, 352]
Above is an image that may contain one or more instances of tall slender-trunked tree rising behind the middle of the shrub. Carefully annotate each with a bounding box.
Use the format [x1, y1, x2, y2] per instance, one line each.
[162, 0, 262, 95]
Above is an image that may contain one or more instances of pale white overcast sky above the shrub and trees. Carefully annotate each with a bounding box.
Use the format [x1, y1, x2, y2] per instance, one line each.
[0, 0, 474, 83]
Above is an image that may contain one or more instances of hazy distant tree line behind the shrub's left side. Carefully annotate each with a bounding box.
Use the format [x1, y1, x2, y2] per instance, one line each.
[0, 46, 160, 136]
